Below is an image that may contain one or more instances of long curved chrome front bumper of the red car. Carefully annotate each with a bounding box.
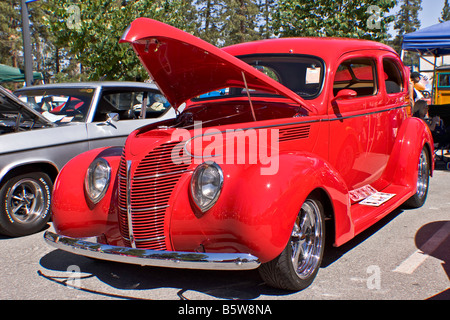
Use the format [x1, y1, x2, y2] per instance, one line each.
[44, 231, 260, 270]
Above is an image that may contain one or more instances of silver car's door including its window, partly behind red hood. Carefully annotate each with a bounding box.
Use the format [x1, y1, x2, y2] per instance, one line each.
[87, 88, 174, 149]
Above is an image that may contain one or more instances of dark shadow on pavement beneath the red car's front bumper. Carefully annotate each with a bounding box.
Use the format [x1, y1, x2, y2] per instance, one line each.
[38, 249, 292, 300]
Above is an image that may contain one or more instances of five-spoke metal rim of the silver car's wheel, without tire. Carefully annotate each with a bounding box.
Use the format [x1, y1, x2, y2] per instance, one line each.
[7, 178, 46, 223]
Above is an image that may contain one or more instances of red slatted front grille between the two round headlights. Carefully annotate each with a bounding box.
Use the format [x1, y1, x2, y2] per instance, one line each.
[119, 142, 189, 250]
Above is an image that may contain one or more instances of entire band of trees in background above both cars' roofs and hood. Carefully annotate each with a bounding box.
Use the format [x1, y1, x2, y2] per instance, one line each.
[0, 0, 414, 82]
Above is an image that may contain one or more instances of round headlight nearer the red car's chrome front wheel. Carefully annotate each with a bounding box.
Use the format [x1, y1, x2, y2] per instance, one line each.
[191, 162, 223, 212]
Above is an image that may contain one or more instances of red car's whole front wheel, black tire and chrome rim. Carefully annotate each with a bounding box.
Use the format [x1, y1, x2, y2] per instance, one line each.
[259, 196, 325, 291]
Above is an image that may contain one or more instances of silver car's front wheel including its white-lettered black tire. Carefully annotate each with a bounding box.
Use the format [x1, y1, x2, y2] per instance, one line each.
[0, 172, 52, 237]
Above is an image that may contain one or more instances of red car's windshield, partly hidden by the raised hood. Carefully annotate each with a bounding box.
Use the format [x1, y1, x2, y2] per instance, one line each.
[193, 54, 324, 101]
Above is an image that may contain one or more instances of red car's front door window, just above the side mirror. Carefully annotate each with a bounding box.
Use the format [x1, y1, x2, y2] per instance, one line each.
[333, 58, 378, 97]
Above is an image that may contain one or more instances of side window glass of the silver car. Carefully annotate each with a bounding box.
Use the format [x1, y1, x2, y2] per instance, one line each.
[94, 91, 170, 122]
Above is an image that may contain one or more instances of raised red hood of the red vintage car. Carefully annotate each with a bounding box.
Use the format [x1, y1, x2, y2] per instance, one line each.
[120, 18, 311, 111]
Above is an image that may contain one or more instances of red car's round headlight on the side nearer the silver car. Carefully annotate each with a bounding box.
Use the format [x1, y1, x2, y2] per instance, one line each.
[84, 158, 111, 203]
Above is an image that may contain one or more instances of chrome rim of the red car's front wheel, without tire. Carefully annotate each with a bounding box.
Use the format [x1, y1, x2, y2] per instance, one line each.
[290, 199, 324, 279]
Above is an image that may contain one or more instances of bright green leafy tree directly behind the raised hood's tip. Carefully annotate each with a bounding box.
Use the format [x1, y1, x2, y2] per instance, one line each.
[40, 0, 197, 80]
